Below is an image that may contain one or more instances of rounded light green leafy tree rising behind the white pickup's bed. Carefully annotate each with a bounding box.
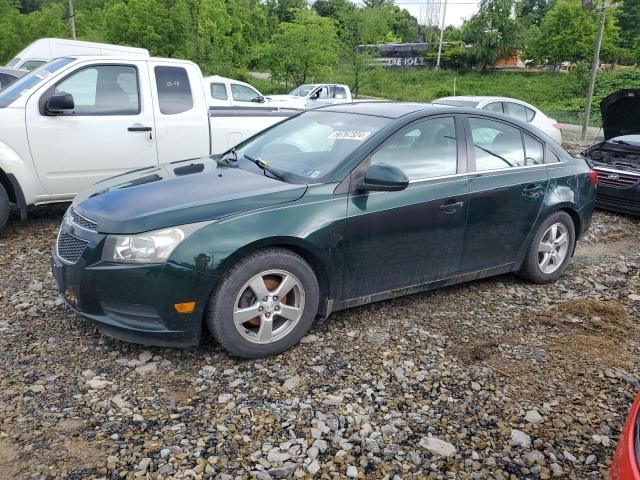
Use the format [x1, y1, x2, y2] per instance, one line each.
[257, 9, 338, 84]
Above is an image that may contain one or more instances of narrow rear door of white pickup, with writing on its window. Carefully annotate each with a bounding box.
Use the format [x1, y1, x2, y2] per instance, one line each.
[149, 62, 210, 163]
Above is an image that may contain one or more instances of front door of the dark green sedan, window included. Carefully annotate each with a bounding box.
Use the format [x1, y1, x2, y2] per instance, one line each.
[343, 116, 468, 299]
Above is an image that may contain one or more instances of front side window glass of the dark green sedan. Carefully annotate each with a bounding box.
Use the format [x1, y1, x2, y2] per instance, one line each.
[371, 117, 458, 180]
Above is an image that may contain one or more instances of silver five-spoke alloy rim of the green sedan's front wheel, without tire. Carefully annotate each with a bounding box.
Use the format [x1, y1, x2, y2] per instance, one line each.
[233, 270, 305, 344]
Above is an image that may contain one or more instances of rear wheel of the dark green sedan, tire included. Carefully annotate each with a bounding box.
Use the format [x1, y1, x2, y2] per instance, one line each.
[519, 212, 576, 283]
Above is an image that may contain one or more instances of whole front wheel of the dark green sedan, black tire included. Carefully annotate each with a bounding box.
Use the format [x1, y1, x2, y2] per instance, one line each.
[206, 248, 320, 358]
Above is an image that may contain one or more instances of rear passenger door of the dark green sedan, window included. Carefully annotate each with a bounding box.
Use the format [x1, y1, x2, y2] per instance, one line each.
[461, 117, 548, 272]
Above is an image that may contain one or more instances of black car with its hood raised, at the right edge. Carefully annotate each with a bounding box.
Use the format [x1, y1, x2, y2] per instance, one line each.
[582, 89, 640, 215]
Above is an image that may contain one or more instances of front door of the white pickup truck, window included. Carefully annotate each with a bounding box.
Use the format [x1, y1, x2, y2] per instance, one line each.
[26, 61, 157, 200]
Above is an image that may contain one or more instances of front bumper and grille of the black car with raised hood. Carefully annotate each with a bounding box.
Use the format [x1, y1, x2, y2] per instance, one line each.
[595, 168, 640, 215]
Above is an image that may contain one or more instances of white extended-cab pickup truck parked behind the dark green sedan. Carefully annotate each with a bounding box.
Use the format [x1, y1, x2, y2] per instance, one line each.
[0, 56, 295, 230]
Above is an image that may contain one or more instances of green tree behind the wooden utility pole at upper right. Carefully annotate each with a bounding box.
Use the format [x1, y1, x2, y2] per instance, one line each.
[527, 0, 619, 65]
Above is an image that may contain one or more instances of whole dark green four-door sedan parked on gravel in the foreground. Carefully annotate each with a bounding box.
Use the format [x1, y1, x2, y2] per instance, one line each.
[52, 102, 597, 357]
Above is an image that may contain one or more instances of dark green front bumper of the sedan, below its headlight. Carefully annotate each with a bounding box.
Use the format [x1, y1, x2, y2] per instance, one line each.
[51, 251, 213, 347]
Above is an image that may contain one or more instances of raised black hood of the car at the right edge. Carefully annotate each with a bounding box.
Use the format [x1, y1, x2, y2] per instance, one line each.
[600, 89, 640, 140]
